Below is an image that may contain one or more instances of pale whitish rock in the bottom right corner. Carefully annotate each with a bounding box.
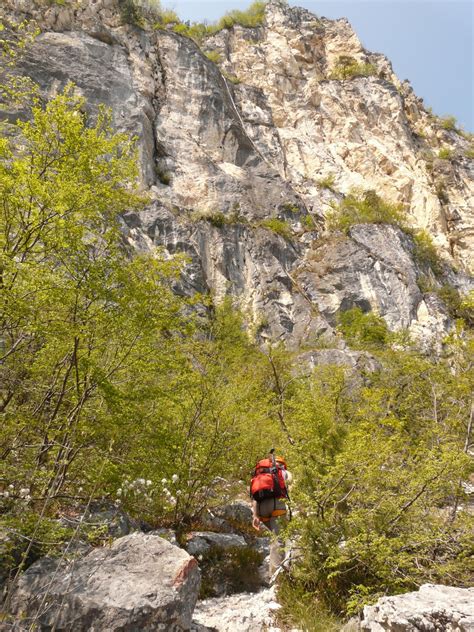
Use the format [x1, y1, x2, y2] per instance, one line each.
[361, 584, 474, 632]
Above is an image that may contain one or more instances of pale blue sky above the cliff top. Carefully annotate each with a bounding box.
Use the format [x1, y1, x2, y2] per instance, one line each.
[162, 0, 474, 132]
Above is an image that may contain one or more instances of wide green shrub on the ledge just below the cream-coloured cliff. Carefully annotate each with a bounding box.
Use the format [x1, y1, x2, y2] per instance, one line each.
[327, 191, 405, 233]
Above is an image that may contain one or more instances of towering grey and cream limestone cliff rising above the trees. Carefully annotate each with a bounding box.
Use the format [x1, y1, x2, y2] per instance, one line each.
[3, 0, 474, 345]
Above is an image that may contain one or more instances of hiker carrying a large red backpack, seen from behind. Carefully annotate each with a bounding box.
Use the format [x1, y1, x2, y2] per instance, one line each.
[250, 449, 292, 577]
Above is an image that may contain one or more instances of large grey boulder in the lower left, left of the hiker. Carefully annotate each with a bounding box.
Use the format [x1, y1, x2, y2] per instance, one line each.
[7, 533, 200, 632]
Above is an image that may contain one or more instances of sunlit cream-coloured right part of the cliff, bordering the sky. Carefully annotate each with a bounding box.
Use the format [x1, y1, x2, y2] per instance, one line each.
[208, 0, 474, 262]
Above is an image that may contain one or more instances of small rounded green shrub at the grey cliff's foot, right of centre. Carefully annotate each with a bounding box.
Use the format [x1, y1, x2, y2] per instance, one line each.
[337, 307, 389, 347]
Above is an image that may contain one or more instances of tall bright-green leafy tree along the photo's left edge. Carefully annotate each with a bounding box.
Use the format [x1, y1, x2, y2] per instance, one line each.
[0, 86, 192, 556]
